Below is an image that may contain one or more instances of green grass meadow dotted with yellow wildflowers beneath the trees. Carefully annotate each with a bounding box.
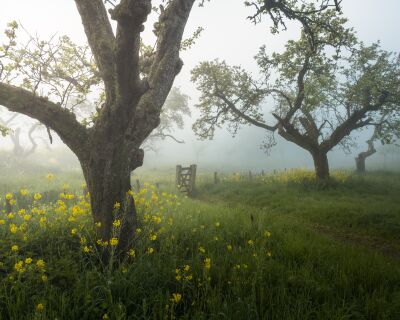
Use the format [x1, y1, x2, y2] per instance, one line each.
[0, 170, 400, 320]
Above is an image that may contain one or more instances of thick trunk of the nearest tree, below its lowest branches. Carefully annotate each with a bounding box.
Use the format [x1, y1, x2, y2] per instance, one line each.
[81, 149, 143, 262]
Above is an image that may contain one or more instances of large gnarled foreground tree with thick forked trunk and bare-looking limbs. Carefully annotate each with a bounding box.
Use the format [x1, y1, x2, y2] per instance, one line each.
[0, 0, 344, 252]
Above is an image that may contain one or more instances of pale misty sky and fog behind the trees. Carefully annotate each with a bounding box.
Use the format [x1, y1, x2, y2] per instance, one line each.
[0, 0, 400, 170]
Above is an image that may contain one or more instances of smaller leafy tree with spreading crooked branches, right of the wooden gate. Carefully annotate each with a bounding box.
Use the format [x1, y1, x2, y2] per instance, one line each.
[192, 10, 400, 179]
